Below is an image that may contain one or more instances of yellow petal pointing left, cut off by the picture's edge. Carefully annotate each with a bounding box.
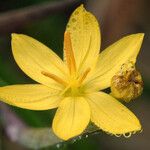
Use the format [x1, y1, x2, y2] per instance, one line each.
[0, 84, 60, 110]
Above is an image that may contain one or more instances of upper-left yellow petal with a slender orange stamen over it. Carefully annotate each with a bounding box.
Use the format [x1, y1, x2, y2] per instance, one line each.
[12, 34, 66, 88]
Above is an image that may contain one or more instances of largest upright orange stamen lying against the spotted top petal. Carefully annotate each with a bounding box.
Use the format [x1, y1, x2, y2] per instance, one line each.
[64, 31, 76, 74]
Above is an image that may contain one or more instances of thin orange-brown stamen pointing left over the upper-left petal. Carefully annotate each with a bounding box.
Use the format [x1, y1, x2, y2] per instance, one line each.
[41, 71, 67, 86]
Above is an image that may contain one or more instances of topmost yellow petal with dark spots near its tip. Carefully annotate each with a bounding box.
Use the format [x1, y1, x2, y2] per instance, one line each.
[66, 5, 100, 71]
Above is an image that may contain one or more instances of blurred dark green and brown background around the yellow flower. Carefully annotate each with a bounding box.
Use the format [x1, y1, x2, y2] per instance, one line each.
[0, 0, 150, 150]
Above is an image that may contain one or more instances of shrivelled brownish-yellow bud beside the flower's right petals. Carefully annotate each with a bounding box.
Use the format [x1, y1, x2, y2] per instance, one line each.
[111, 62, 143, 102]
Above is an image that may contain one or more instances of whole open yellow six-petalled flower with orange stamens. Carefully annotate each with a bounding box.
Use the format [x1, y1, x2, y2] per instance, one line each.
[0, 5, 144, 140]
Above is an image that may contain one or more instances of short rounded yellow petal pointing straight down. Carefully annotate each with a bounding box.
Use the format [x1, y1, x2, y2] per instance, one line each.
[53, 97, 90, 140]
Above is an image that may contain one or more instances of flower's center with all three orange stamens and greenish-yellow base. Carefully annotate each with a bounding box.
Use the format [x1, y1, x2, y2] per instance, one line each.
[41, 32, 91, 96]
